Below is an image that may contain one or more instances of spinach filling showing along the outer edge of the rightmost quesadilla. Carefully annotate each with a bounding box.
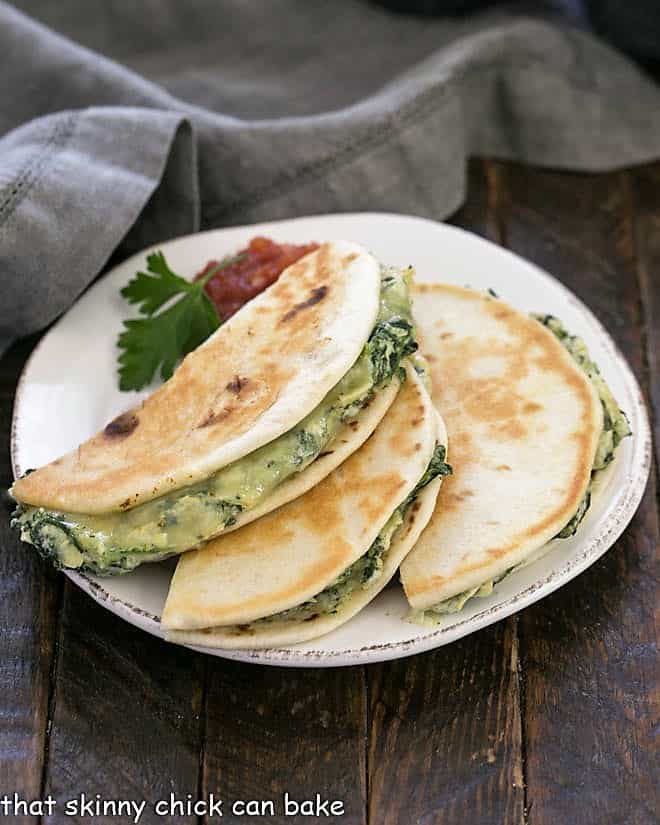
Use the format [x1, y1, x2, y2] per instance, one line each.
[408, 315, 631, 624]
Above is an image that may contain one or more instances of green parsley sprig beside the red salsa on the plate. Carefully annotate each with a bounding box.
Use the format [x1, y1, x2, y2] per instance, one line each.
[117, 251, 242, 391]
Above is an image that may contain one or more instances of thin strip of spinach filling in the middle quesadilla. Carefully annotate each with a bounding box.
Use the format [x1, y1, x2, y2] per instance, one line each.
[236, 444, 452, 633]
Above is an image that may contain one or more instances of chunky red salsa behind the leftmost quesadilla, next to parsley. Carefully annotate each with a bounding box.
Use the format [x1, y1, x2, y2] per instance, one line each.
[195, 238, 319, 321]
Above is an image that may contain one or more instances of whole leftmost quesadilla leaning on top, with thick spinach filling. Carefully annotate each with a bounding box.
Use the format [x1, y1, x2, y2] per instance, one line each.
[11, 241, 417, 575]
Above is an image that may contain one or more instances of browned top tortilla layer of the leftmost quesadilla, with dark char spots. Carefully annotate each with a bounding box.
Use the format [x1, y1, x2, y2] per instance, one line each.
[12, 241, 380, 514]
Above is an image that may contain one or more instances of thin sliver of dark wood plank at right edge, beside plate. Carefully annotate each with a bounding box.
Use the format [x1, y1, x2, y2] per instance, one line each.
[628, 163, 660, 474]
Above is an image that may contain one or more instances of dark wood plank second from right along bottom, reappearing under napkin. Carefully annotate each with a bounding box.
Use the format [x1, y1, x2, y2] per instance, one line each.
[368, 161, 525, 825]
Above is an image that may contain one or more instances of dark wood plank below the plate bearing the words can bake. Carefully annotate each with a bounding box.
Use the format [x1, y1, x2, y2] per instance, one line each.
[202, 660, 366, 825]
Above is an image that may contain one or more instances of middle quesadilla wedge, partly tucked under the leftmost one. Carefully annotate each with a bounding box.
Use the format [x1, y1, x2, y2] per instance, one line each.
[161, 361, 450, 648]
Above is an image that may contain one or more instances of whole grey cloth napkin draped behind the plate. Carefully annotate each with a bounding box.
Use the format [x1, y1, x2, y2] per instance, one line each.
[0, 0, 660, 352]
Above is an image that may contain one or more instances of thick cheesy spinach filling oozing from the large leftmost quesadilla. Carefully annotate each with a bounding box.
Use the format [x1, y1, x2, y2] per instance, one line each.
[12, 267, 417, 575]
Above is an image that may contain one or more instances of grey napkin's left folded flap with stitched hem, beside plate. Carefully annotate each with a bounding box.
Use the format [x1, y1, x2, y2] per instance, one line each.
[0, 107, 199, 353]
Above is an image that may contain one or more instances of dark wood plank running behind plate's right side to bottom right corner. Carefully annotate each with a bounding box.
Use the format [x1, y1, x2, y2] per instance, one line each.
[501, 164, 660, 825]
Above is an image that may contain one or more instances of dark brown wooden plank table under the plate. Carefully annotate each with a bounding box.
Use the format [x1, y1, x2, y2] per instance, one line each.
[0, 161, 660, 825]
